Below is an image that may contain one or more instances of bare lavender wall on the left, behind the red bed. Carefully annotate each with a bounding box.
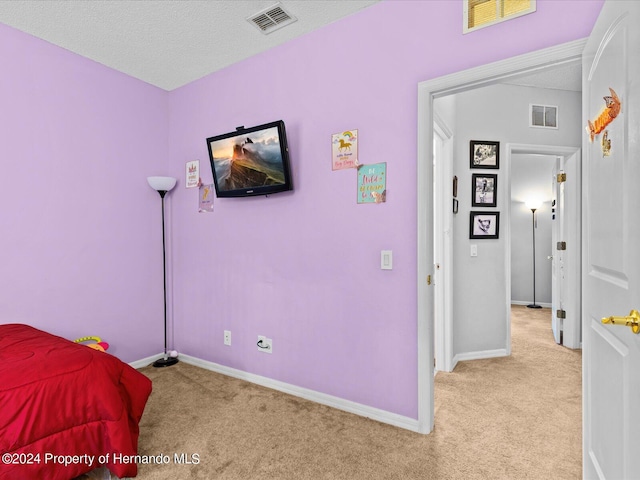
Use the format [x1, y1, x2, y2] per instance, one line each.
[0, 25, 169, 361]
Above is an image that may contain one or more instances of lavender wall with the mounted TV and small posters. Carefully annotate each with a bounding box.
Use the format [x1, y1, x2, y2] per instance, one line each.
[169, 0, 602, 418]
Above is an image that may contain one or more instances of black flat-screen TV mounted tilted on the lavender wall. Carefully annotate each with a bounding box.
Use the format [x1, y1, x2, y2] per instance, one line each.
[207, 120, 293, 197]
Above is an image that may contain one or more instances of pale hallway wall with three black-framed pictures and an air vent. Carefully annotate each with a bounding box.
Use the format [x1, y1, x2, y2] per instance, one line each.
[453, 85, 583, 356]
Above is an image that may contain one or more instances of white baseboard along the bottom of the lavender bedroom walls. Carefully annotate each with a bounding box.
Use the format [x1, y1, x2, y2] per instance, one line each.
[161, 354, 419, 432]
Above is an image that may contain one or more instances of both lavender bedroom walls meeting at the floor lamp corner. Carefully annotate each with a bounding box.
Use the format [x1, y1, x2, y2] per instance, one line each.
[0, 0, 601, 418]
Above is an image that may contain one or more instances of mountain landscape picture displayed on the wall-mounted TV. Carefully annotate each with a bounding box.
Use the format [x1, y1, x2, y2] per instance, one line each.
[210, 127, 285, 191]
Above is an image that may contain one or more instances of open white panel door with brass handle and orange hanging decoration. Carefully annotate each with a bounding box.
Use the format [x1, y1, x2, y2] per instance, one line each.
[583, 0, 640, 480]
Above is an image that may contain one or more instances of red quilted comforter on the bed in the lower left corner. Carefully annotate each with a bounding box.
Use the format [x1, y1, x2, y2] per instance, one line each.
[0, 324, 151, 480]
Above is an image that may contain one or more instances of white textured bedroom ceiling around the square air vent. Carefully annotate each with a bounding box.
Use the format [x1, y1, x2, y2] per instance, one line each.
[0, 0, 379, 90]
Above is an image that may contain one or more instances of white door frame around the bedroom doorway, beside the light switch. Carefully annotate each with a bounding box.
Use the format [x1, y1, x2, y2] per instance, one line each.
[417, 39, 586, 433]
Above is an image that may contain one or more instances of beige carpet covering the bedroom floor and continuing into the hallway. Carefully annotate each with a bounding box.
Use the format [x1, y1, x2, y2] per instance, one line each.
[117, 306, 582, 480]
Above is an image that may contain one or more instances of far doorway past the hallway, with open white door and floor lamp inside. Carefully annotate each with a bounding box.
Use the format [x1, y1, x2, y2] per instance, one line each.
[507, 144, 582, 349]
